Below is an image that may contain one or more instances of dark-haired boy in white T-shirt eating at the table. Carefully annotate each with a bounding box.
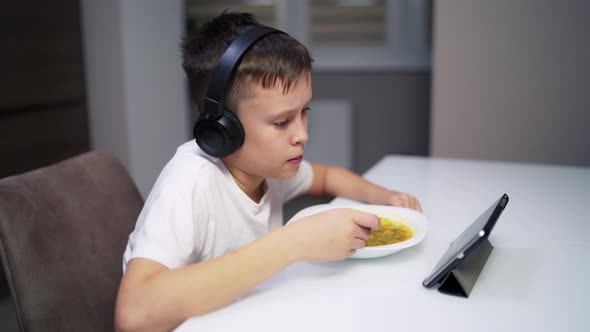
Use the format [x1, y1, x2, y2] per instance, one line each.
[115, 12, 421, 331]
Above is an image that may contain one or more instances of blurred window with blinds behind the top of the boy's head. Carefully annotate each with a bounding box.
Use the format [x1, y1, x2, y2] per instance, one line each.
[187, 0, 432, 71]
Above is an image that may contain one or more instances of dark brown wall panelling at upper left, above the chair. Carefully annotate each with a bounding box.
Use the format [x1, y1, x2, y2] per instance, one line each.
[0, 0, 90, 178]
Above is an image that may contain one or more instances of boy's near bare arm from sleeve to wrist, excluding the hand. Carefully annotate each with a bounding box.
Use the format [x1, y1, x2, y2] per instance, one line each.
[116, 230, 292, 331]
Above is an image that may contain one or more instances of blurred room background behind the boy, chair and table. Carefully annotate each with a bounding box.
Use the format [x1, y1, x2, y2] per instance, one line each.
[0, 0, 590, 331]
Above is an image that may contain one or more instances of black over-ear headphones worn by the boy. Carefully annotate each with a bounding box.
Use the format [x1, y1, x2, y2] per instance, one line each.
[193, 26, 284, 158]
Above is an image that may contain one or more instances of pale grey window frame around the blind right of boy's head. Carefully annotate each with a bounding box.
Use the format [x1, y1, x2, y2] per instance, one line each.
[273, 0, 431, 71]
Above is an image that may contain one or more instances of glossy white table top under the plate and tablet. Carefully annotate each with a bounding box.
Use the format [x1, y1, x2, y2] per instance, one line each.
[177, 156, 590, 332]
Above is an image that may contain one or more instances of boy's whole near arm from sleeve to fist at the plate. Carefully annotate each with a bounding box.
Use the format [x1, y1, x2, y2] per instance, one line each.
[115, 209, 380, 331]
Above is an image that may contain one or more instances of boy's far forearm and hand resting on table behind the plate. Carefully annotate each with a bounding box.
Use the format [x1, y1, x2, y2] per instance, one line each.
[307, 163, 422, 211]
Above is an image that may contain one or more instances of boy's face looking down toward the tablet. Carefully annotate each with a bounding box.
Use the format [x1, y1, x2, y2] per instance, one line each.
[224, 73, 311, 181]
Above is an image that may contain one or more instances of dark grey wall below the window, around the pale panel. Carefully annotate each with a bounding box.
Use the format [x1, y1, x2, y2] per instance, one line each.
[313, 71, 430, 173]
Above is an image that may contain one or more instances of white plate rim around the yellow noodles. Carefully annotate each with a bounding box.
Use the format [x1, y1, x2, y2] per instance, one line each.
[287, 204, 428, 258]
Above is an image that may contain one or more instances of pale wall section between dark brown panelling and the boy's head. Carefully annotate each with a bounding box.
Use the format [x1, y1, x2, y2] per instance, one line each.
[81, 0, 190, 197]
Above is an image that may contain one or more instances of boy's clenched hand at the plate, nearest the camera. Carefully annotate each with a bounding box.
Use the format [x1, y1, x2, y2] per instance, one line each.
[284, 209, 381, 261]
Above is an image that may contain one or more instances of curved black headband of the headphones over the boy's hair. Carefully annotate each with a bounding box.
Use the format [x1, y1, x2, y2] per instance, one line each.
[204, 26, 284, 118]
